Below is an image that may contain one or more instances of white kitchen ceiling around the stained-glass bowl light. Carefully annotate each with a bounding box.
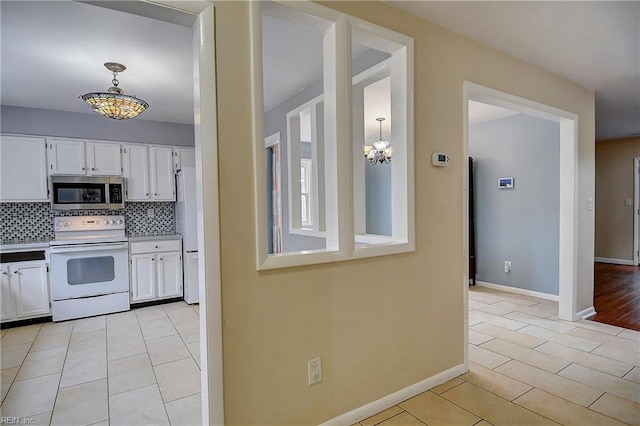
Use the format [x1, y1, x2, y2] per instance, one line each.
[0, 1, 193, 124]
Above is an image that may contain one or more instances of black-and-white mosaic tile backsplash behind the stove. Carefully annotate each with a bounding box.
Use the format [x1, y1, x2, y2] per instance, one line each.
[0, 202, 175, 244]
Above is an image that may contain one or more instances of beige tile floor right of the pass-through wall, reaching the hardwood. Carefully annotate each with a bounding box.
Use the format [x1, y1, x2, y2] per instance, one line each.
[359, 287, 640, 426]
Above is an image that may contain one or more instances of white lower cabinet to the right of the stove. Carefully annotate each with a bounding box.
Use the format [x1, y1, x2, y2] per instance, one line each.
[129, 240, 182, 303]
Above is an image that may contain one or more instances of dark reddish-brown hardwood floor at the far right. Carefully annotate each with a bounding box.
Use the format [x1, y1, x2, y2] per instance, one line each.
[589, 263, 640, 331]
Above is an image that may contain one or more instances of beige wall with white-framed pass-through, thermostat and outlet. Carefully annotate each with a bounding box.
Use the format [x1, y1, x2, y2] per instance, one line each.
[210, 2, 594, 424]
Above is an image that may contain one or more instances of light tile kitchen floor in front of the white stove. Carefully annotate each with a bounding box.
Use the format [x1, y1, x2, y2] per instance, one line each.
[0, 302, 201, 426]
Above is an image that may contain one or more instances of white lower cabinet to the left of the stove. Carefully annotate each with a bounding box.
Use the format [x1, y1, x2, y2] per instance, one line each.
[0, 261, 51, 322]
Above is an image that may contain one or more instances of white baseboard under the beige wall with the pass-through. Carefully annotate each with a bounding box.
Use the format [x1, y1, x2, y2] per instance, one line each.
[322, 364, 467, 426]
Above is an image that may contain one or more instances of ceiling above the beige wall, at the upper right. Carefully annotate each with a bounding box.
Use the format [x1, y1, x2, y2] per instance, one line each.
[387, 1, 640, 140]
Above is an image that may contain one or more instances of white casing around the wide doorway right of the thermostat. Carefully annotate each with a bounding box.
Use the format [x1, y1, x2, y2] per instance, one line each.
[463, 81, 580, 364]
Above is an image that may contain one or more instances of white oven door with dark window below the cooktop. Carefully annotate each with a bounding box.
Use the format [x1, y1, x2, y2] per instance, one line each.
[51, 243, 129, 300]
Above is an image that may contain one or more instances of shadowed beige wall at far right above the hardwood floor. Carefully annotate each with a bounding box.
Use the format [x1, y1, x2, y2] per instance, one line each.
[596, 138, 640, 261]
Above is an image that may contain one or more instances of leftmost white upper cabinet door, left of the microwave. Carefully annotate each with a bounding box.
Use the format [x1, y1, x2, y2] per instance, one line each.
[0, 136, 49, 201]
